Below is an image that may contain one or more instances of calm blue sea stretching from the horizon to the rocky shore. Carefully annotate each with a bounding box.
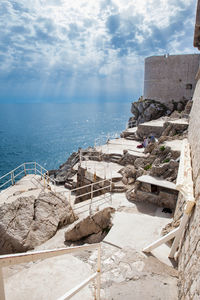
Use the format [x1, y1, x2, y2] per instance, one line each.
[0, 102, 131, 177]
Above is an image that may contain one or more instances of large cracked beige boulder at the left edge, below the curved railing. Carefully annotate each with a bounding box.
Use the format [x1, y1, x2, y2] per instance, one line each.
[0, 192, 75, 254]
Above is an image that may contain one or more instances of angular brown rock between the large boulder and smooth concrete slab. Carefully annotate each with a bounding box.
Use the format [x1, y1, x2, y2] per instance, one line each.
[65, 207, 115, 242]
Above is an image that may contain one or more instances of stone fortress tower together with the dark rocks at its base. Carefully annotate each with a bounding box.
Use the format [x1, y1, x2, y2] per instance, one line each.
[128, 54, 200, 127]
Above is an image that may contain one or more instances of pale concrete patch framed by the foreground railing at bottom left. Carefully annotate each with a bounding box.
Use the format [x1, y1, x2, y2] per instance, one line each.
[5, 254, 94, 300]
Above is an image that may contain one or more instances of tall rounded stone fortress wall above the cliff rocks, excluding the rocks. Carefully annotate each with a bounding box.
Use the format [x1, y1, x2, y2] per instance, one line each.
[143, 54, 200, 105]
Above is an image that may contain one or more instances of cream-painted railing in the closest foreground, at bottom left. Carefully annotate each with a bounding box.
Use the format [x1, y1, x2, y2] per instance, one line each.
[0, 243, 101, 300]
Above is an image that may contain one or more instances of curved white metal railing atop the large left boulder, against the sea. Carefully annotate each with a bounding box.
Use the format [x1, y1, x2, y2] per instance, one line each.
[0, 162, 56, 190]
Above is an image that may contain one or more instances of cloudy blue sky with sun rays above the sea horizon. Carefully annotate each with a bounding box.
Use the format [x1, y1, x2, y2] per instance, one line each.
[0, 0, 198, 103]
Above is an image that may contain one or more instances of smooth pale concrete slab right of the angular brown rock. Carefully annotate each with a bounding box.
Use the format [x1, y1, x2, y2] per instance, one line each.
[104, 209, 172, 265]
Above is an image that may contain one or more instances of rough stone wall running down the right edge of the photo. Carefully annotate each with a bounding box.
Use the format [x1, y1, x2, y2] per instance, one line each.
[179, 79, 200, 300]
